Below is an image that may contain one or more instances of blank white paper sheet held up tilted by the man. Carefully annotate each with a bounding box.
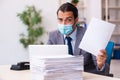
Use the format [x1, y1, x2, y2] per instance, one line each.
[79, 18, 115, 56]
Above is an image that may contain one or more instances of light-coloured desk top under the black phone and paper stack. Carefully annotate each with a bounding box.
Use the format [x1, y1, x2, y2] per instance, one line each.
[0, 65, 120, 80]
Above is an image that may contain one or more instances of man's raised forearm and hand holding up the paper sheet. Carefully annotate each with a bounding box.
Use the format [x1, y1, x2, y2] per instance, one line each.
[92, 49, 110, 75]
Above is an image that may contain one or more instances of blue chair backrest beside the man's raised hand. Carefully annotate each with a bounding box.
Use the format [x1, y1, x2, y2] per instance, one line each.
[106, 41, 114, 65]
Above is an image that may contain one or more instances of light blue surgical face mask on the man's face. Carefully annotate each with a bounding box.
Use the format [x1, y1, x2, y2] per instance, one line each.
[58, 24, 73, 35]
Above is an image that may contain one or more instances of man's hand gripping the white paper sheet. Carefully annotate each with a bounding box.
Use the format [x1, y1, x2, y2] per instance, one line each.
[96, 49, 107, 69]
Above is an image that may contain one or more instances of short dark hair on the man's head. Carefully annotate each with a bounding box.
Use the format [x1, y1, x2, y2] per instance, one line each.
[57, 2, 78, 19]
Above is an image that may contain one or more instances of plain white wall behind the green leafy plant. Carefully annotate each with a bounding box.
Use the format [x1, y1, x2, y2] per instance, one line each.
[0, 0, 58, 64]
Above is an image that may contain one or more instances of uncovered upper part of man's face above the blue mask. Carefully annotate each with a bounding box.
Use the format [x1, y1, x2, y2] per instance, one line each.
[57, 11, 77, 30]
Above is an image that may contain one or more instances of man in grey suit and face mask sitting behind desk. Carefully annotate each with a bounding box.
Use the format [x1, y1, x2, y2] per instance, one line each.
[47, 2, 109, 75]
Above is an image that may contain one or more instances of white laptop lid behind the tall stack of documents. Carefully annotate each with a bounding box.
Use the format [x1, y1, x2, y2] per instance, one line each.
[29, 45, 68, 58]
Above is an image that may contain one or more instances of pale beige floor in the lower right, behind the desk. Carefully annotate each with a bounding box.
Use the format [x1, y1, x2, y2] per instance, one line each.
[110, 59, 120, 78]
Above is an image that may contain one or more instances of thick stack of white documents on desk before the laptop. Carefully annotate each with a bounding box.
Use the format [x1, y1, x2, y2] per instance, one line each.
[30, 56, 83, 80]
